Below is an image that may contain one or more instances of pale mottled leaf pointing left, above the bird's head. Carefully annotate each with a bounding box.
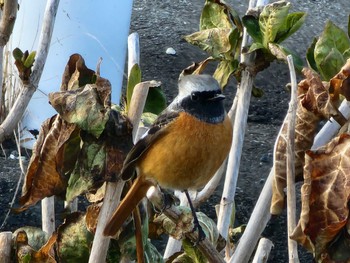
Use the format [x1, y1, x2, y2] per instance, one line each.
[184, 28, 233, 58]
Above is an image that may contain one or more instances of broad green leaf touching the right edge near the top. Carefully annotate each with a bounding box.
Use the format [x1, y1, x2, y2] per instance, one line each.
[314, 21, 350, 80]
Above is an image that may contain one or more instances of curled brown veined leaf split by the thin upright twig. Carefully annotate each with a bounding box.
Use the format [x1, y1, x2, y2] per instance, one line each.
[270, 69, 338, 215]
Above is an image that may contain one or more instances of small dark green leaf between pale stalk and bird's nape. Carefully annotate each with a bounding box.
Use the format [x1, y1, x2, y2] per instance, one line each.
[143, 87, 167, 115]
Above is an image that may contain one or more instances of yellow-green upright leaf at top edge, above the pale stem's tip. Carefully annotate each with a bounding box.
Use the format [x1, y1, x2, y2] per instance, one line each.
[259, 1, 290, 48]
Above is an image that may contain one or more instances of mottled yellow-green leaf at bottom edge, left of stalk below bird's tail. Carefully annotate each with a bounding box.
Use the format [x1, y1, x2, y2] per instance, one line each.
[57, 212, 93, 263]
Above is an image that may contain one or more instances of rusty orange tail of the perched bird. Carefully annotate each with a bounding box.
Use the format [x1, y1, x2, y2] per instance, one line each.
[103, 176, 153, 236]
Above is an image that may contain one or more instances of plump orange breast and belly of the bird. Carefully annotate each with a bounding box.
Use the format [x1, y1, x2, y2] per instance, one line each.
[138, 115, 232, 190]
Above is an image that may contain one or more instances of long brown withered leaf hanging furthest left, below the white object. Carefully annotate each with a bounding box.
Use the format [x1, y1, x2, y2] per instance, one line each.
[15, 115, 77, 212]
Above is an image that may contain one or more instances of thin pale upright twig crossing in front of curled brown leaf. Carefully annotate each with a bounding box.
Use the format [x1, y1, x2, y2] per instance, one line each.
[287, 55, 299, 262]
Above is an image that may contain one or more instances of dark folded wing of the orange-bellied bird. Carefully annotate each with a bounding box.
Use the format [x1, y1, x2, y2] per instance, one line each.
[120, 111, 179, 180]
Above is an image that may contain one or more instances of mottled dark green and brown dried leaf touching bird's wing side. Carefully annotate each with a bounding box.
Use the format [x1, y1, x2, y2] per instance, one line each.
[66, 110, 132, 201]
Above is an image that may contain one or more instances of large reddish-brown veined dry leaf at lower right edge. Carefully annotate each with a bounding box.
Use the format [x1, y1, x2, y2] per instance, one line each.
[291, 134, 350, 262]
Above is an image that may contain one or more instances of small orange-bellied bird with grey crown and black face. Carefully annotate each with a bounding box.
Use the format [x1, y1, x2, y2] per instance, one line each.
[104, 74, 232, 240]
